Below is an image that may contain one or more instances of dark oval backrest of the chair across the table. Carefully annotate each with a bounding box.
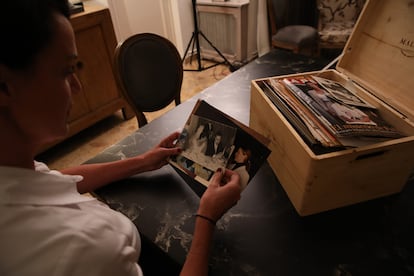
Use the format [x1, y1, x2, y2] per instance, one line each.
[114, 33, 183, 127]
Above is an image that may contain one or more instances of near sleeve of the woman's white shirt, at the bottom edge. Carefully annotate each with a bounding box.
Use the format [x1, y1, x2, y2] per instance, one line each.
[55, 212, 143, 276]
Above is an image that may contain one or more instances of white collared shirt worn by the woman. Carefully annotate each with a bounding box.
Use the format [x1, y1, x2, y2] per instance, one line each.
[0, 162, 142, 276]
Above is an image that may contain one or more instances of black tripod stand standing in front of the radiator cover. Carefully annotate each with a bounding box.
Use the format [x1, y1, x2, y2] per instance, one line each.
[182, 0, 236, 72]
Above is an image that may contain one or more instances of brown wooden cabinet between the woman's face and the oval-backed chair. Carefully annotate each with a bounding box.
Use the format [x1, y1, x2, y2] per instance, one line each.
[68, 5, 132, 137]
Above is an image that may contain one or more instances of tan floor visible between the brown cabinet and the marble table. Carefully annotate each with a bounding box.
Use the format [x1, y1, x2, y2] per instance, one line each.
[36, 61, 230, 170]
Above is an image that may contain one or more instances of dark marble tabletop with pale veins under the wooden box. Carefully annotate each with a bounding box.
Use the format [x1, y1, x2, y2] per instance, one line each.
[88, 50, 414, 276]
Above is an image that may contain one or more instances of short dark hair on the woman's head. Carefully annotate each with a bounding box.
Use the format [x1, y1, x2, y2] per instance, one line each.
[0, 0, 70, 70]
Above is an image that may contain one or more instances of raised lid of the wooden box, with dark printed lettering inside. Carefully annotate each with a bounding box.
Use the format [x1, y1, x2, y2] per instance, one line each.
[337, 0, 414, 122]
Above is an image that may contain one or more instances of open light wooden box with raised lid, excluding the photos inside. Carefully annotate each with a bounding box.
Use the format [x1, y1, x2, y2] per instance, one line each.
[250, 0, 414, 216]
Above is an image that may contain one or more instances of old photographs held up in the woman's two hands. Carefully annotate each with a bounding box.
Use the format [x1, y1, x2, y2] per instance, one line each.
[170, 101, 270, 189]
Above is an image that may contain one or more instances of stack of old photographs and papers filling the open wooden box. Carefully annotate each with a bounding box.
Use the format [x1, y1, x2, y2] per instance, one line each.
[257, 76, 402, 153]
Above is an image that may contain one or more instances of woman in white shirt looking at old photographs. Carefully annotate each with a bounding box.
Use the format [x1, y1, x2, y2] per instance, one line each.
[0, 0, 240, 276]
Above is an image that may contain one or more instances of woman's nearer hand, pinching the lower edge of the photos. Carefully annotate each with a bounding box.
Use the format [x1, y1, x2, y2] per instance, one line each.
[198, 169, 241, 221]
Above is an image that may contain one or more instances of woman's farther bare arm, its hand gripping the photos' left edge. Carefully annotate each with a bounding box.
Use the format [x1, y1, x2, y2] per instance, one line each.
[62, 132, 181, 193]
